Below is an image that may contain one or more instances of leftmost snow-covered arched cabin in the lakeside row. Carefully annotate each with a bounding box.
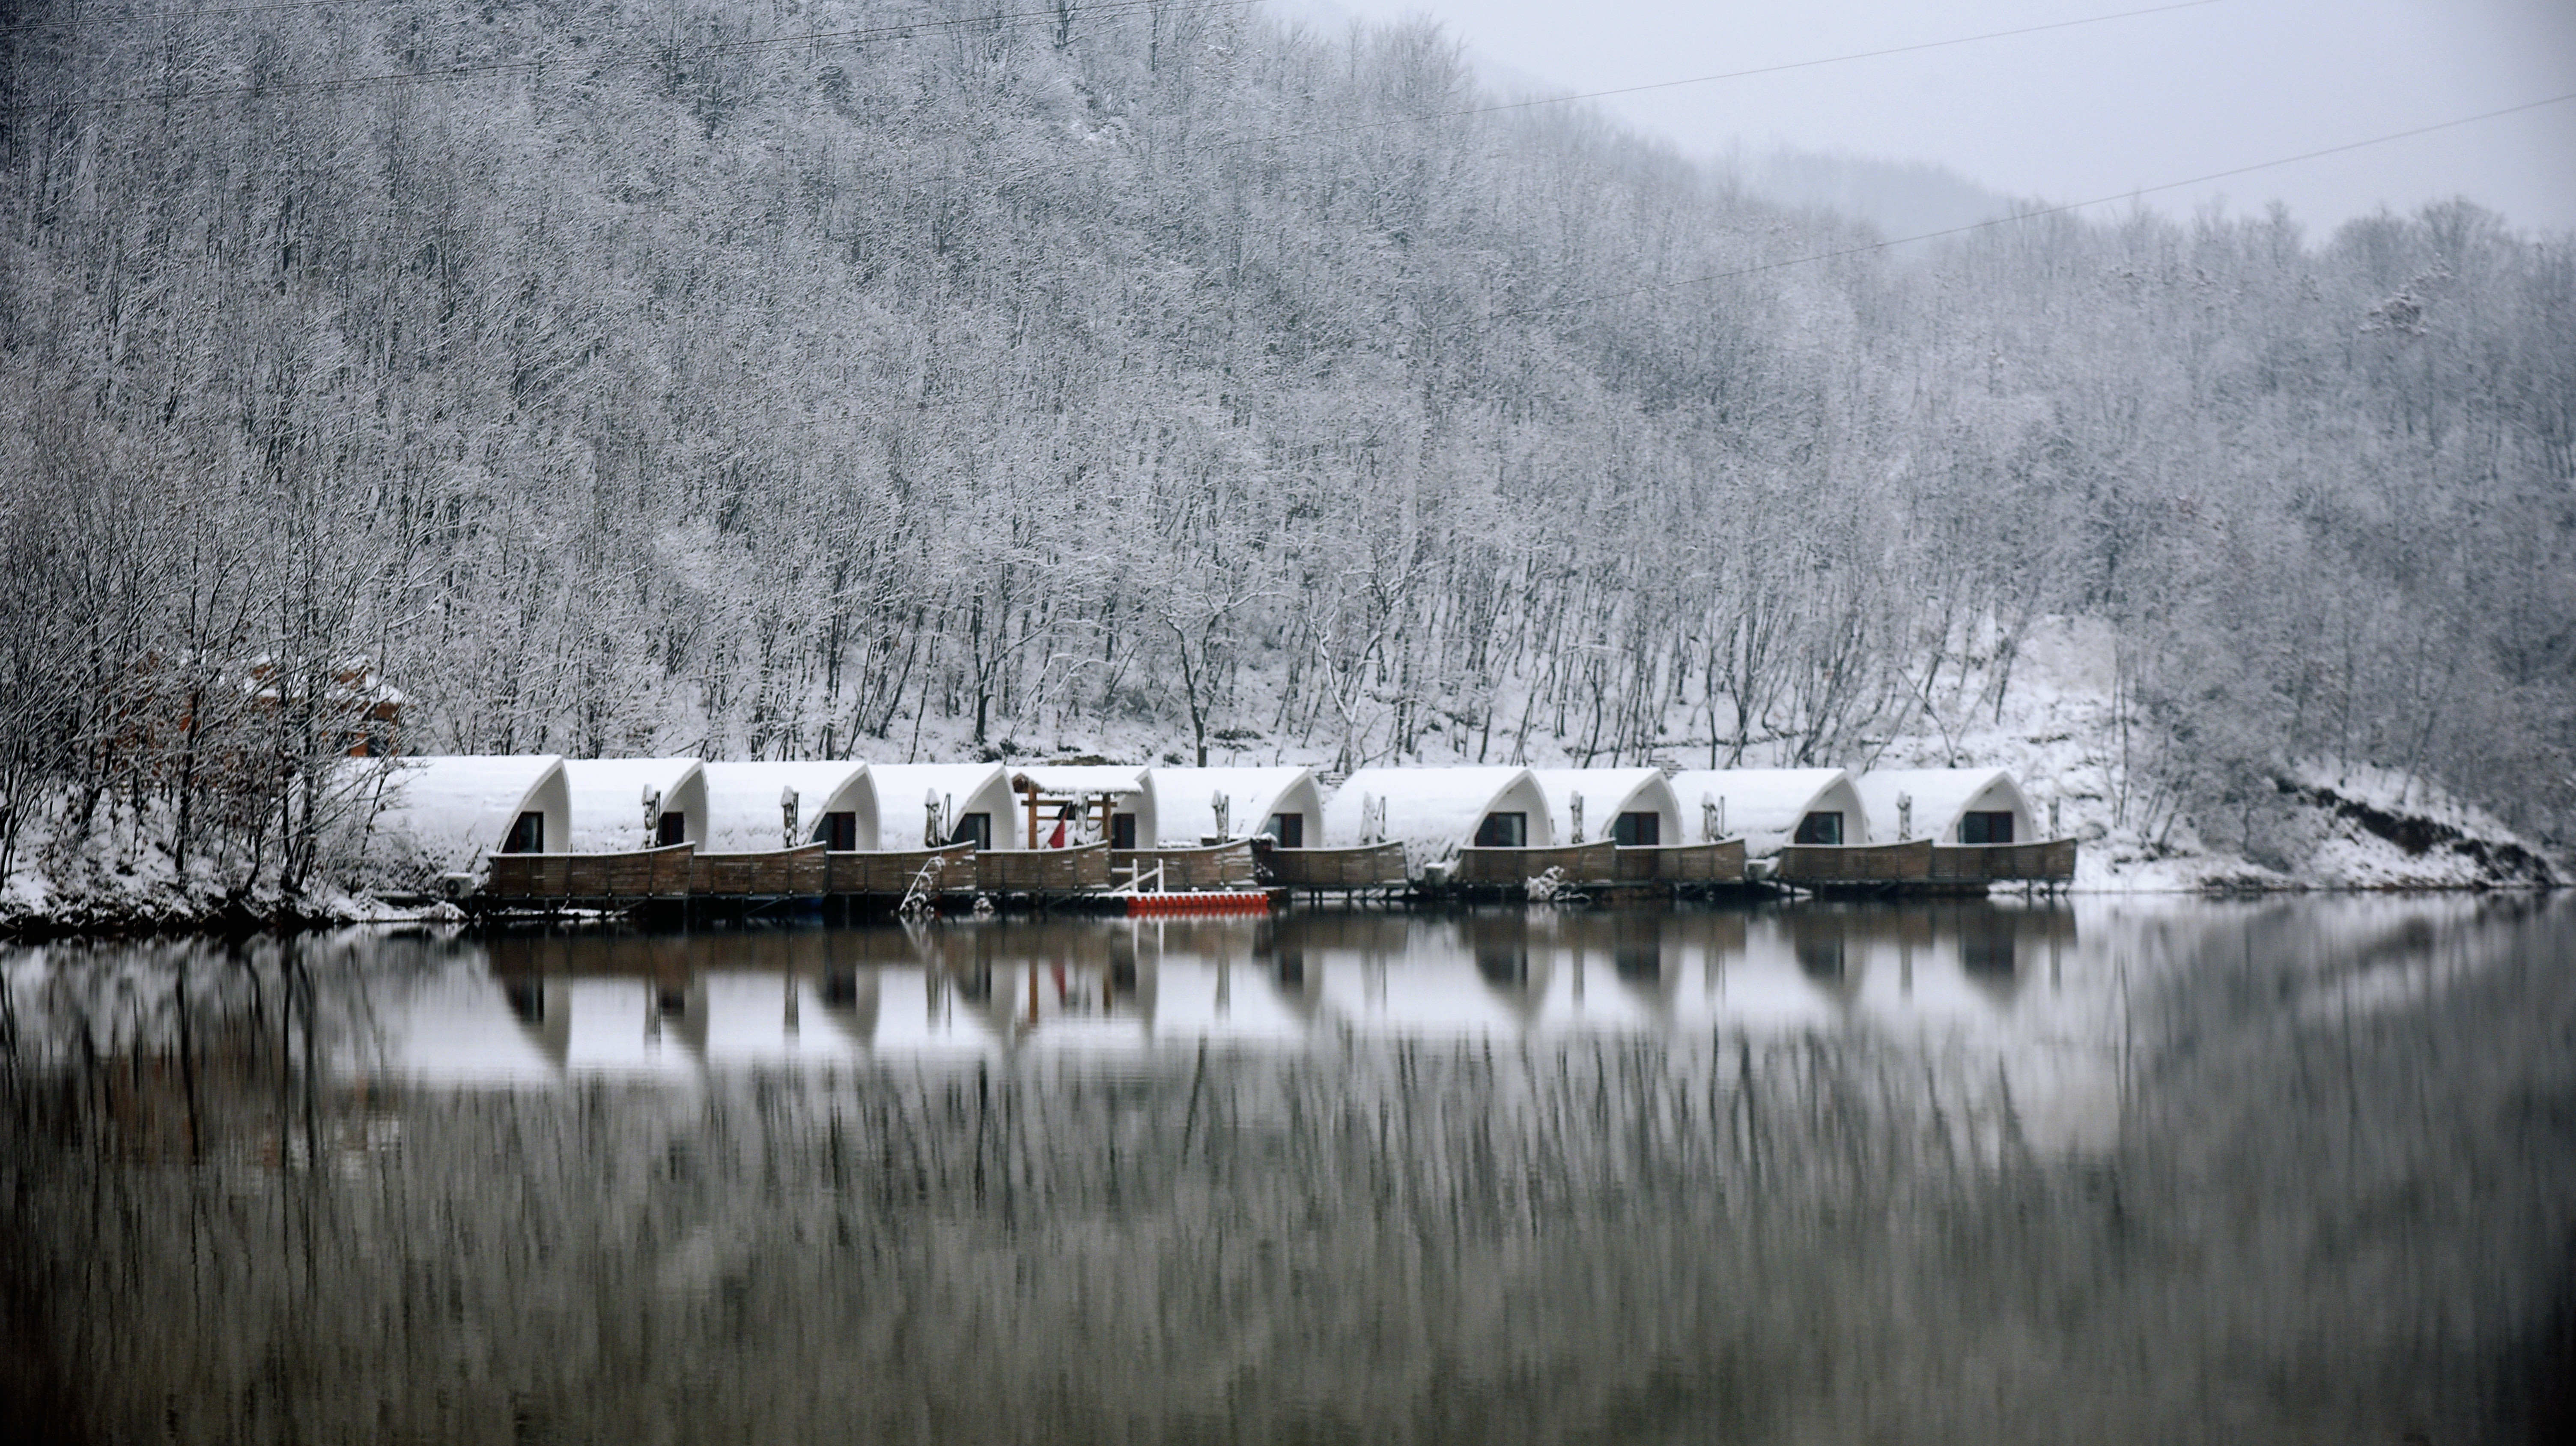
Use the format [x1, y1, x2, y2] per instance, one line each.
[350, 753, 572, 881]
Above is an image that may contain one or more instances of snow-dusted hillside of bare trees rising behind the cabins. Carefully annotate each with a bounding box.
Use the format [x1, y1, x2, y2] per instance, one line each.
[0, 0, 2576, 884]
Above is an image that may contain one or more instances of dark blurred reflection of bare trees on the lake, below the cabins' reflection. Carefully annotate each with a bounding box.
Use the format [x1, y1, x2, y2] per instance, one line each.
[0, 910, 2576, 1441]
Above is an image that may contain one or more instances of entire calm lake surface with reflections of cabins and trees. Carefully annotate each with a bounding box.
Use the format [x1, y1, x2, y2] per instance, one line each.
[0, 897, 2576, 1446]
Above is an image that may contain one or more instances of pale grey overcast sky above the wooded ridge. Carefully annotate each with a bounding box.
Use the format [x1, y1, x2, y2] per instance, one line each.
[1275, 0, 2576, 235]
